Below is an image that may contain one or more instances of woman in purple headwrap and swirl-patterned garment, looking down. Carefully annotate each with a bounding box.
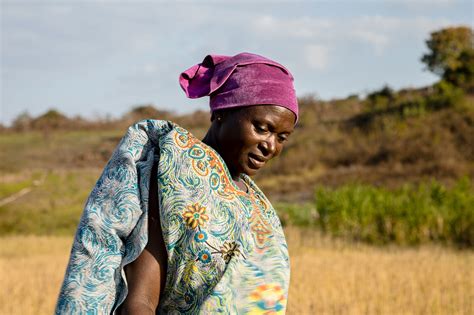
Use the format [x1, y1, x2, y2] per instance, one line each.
[56, 53, 298, 314]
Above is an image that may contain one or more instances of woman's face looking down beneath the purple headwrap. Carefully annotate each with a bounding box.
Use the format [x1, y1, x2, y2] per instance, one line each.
[215, 105, 295, 177]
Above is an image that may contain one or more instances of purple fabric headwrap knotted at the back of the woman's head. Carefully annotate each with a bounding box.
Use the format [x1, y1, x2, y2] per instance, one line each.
[179, 53, 298, 120]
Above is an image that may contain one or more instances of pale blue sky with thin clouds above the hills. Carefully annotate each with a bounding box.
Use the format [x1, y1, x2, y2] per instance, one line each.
[0, 0, 473, 124]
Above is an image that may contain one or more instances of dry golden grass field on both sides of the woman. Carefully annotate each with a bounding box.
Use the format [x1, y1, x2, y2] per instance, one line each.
[0, 228, 474, 314]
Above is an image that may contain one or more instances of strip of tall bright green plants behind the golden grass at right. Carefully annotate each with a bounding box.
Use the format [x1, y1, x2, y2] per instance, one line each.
[315, 178, 474, 247]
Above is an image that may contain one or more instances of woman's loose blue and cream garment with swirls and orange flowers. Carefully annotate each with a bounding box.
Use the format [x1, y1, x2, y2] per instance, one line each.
[56, 120, 289, 314]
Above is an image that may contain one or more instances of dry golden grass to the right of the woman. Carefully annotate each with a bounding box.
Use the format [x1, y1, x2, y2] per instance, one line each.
[287, 229, 474, 314]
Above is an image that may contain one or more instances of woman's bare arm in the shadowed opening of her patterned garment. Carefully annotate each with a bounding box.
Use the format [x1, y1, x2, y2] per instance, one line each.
[117, 164, 167, 314]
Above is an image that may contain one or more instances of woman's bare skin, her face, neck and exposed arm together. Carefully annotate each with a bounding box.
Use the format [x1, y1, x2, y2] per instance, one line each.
[117, 105, 295, 314]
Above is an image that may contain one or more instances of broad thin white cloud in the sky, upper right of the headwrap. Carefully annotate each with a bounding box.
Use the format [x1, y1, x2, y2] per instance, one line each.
[251, 15, 458, 56]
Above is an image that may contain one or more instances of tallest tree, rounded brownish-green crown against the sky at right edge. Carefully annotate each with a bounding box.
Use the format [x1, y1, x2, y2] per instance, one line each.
[421, 26, 474, 88]
